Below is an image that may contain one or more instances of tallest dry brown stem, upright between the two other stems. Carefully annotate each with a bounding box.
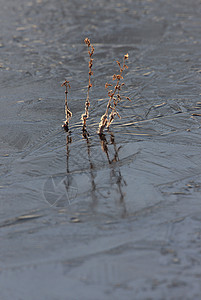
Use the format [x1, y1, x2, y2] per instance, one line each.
[81, 38, 94, 135]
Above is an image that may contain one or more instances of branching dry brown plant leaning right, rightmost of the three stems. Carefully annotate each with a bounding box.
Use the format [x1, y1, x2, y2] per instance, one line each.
[98, 54, 130, 135]
